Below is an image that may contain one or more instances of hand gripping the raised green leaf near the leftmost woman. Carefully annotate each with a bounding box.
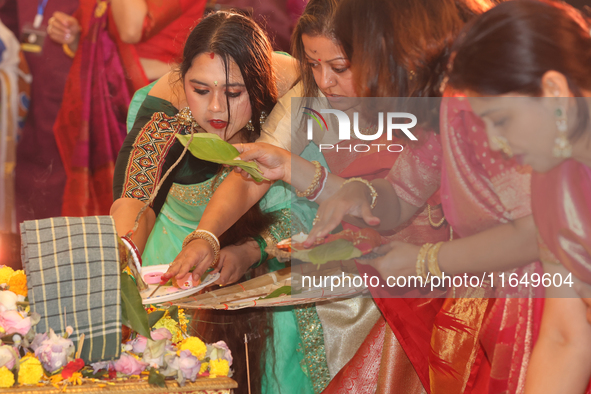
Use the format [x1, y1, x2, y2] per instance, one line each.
[234, 142, 291, 183]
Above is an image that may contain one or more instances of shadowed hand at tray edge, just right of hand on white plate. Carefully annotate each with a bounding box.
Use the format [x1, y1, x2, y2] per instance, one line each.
[212, 241, 261, 286]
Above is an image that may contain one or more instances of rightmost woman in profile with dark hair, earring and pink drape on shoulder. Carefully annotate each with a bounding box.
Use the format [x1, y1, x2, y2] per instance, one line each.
[446, 1, 591, 393]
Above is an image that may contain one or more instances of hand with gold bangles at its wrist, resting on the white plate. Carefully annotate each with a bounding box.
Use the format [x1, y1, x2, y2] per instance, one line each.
[161, 239, 214, 286]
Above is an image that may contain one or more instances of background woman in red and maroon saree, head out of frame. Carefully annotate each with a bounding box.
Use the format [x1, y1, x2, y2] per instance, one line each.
[48, 0, 205, 216]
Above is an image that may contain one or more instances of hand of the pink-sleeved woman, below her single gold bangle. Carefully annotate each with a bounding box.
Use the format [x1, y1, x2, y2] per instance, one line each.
[304, 182, 380, 248]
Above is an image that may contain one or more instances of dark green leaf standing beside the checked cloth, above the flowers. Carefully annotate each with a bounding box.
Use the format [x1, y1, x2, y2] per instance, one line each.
[121, 272, 150, 338]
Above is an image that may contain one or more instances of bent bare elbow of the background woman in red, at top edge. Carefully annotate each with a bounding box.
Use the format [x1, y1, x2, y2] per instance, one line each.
[111, 0, 148, 44]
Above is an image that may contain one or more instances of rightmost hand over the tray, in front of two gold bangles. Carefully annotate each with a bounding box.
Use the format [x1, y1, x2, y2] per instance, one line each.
[356, 241, 421, 280]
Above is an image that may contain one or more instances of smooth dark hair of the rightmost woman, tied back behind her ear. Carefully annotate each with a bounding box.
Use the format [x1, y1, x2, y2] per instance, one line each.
[448, 0, 591, 142]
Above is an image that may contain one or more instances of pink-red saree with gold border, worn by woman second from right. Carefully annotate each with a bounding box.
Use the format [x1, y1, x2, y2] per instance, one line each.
[430, 98, 543, 393]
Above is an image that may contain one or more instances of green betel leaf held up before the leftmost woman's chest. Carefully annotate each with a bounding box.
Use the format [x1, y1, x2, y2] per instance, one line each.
[176, 133, 268, 182]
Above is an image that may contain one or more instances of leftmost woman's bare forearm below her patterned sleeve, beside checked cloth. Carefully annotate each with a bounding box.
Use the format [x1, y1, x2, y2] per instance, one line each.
[110, 198, 156, 252]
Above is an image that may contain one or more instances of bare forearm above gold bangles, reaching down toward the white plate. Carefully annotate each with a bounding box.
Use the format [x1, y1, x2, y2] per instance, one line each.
[199, 172, 271, 237]
